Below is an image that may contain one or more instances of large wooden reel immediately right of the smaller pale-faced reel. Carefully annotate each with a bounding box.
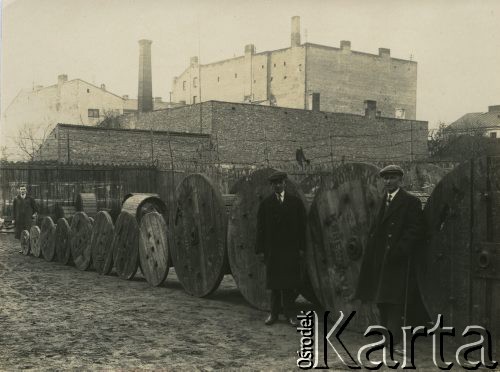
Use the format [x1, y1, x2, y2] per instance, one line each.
[171, 174, 228, 297]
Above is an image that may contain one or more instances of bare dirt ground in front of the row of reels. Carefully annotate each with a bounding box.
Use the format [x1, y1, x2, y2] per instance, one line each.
[0, 234, 498, 371]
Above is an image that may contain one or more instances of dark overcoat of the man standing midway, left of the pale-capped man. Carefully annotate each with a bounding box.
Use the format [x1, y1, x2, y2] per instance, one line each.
[255, 191, 306, 289]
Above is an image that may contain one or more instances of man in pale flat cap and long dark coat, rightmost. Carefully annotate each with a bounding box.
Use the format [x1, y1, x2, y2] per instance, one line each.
[356, 165, 423, 351]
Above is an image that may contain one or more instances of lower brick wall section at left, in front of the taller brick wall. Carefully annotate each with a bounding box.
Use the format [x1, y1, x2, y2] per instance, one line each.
[35, 124, 212, 169]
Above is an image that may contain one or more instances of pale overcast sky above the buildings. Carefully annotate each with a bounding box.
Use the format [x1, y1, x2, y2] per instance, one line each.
[0, 0, 500, 132]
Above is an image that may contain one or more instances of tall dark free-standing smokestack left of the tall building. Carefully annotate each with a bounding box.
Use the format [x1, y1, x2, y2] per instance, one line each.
[137, 39, 153, 112]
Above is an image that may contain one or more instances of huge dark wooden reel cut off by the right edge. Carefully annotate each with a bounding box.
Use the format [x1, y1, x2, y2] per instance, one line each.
[418, 157, 500, 335]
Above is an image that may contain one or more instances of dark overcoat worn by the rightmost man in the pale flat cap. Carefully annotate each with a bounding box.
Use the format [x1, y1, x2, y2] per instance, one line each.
[356, 188, 424, 304]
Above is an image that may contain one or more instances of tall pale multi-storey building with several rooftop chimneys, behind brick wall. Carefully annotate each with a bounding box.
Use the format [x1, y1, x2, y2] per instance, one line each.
[172, 17, 417, 119]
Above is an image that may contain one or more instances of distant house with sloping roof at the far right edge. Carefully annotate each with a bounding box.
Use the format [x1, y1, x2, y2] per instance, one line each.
[445, 105, 500, 138]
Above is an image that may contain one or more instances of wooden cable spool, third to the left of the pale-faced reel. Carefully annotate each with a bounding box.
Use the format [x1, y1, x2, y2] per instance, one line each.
[70, 212, 92, 270]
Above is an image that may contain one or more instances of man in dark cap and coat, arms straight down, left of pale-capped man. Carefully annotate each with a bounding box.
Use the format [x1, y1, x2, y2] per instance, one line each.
[255, 172, 306, 326]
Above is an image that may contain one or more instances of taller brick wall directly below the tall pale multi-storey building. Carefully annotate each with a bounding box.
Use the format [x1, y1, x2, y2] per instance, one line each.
[111, 101, 427, 168]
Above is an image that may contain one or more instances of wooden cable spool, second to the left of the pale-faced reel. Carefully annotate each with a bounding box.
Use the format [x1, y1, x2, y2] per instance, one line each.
[90, 211, 115, 275]
